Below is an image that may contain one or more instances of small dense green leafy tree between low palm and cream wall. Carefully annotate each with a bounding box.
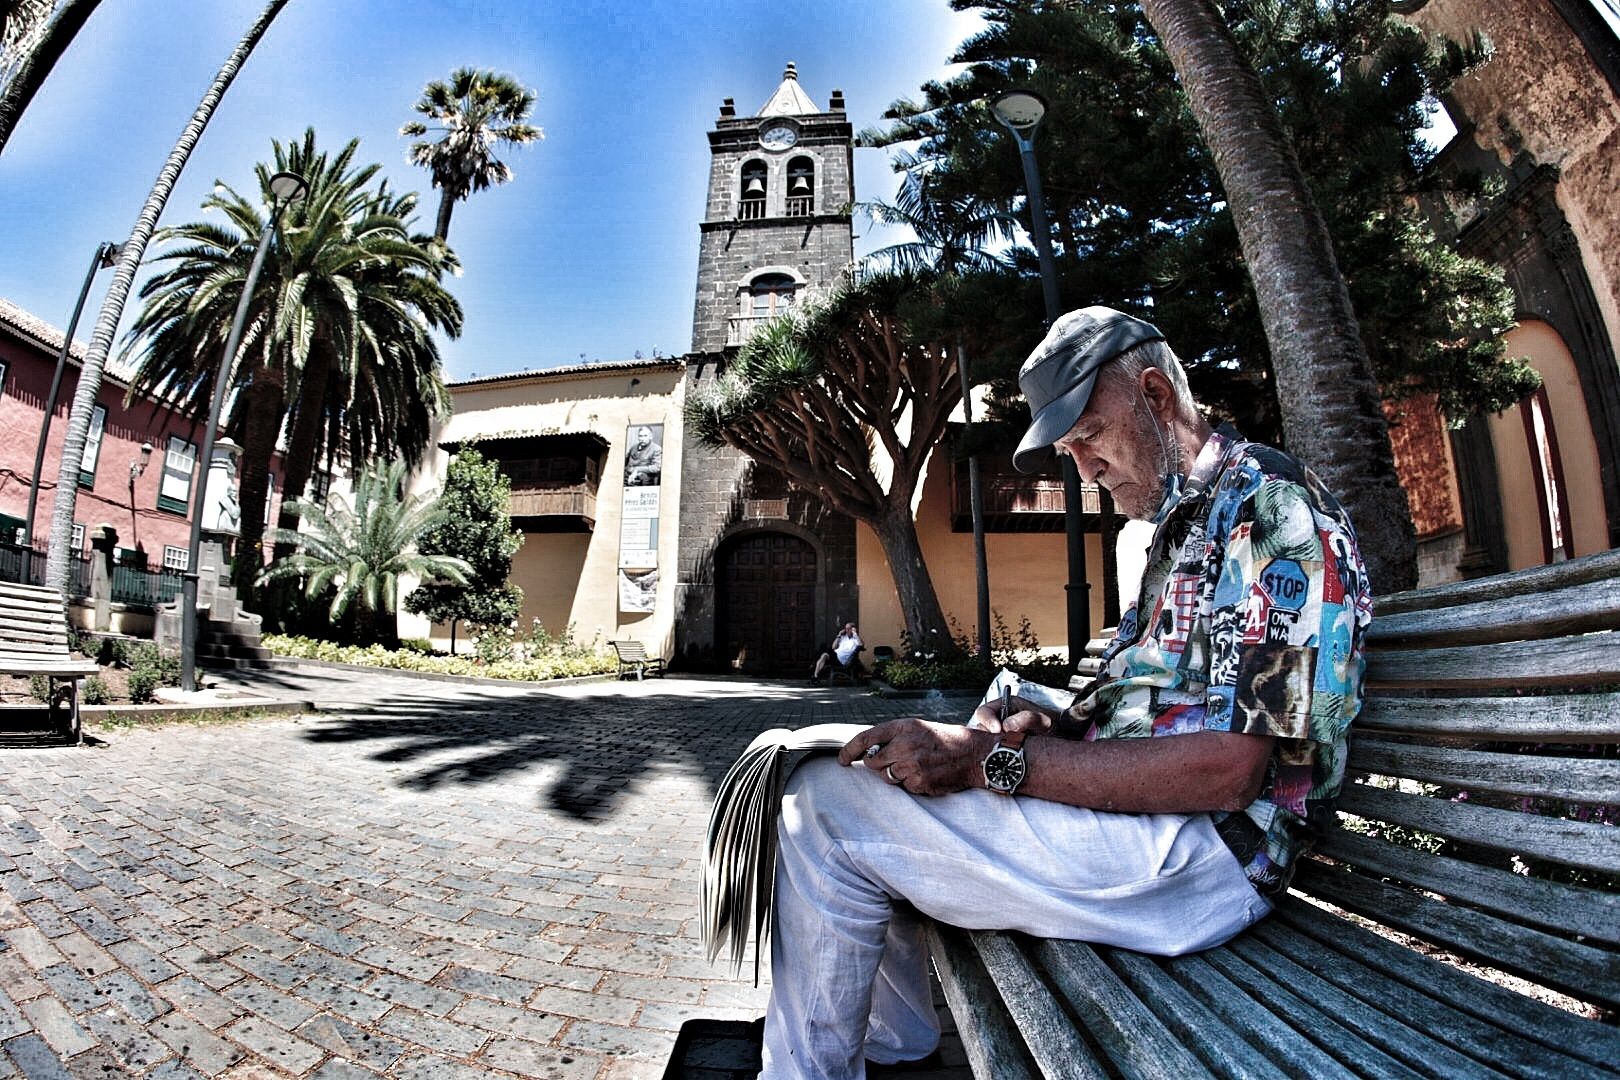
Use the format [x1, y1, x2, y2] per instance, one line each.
[405, 447, 523, 651]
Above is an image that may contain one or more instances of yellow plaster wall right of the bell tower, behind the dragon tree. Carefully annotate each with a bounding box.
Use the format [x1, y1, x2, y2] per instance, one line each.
[855, 446, 1103, 651]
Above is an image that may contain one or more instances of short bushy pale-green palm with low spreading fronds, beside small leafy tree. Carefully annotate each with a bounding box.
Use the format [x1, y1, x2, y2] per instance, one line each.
[259, 458, 471, 643]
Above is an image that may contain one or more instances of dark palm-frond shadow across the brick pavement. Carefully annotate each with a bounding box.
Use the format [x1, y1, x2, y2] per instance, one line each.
[291, 680, 939, 821]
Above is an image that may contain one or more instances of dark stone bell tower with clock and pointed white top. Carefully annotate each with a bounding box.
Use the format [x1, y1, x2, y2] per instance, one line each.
[676, 63, 857, 672]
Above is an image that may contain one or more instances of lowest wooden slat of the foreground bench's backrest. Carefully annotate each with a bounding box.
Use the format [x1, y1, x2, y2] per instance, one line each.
[1298, 861, 1620, 1006]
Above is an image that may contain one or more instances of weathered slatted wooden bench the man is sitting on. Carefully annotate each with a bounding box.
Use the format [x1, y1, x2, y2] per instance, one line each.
[928, 551, 1620, 1080]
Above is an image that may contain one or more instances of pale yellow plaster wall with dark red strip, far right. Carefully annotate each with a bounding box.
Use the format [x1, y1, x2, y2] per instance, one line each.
[1490, 319, 1609, 570]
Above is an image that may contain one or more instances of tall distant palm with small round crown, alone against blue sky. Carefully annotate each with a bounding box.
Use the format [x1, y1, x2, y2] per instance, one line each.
[400, 68, 546, 240]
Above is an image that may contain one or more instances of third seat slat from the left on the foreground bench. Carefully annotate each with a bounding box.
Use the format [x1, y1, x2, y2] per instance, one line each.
[1035, 939, 1213, 1080]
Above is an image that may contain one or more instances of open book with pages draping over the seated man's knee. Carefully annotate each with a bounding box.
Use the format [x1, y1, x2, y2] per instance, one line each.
[701, 669, 1074, 984]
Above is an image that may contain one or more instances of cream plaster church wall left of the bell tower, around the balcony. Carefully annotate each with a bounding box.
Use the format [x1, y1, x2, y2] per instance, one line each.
[400, 366, 685, 656]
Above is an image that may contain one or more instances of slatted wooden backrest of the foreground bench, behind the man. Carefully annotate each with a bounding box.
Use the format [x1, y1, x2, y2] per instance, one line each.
[1294, 551, 1620, 1023]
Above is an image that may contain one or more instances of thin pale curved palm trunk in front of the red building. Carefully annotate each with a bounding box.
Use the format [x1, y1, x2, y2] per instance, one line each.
[45, 0, 287, 591]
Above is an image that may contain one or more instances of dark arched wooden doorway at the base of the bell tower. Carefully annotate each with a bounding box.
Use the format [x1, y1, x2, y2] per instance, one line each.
[714, 531, 816, 674]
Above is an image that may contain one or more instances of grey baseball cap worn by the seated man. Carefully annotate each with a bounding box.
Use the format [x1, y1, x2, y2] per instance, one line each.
[1013, 308, 1165, 473]
